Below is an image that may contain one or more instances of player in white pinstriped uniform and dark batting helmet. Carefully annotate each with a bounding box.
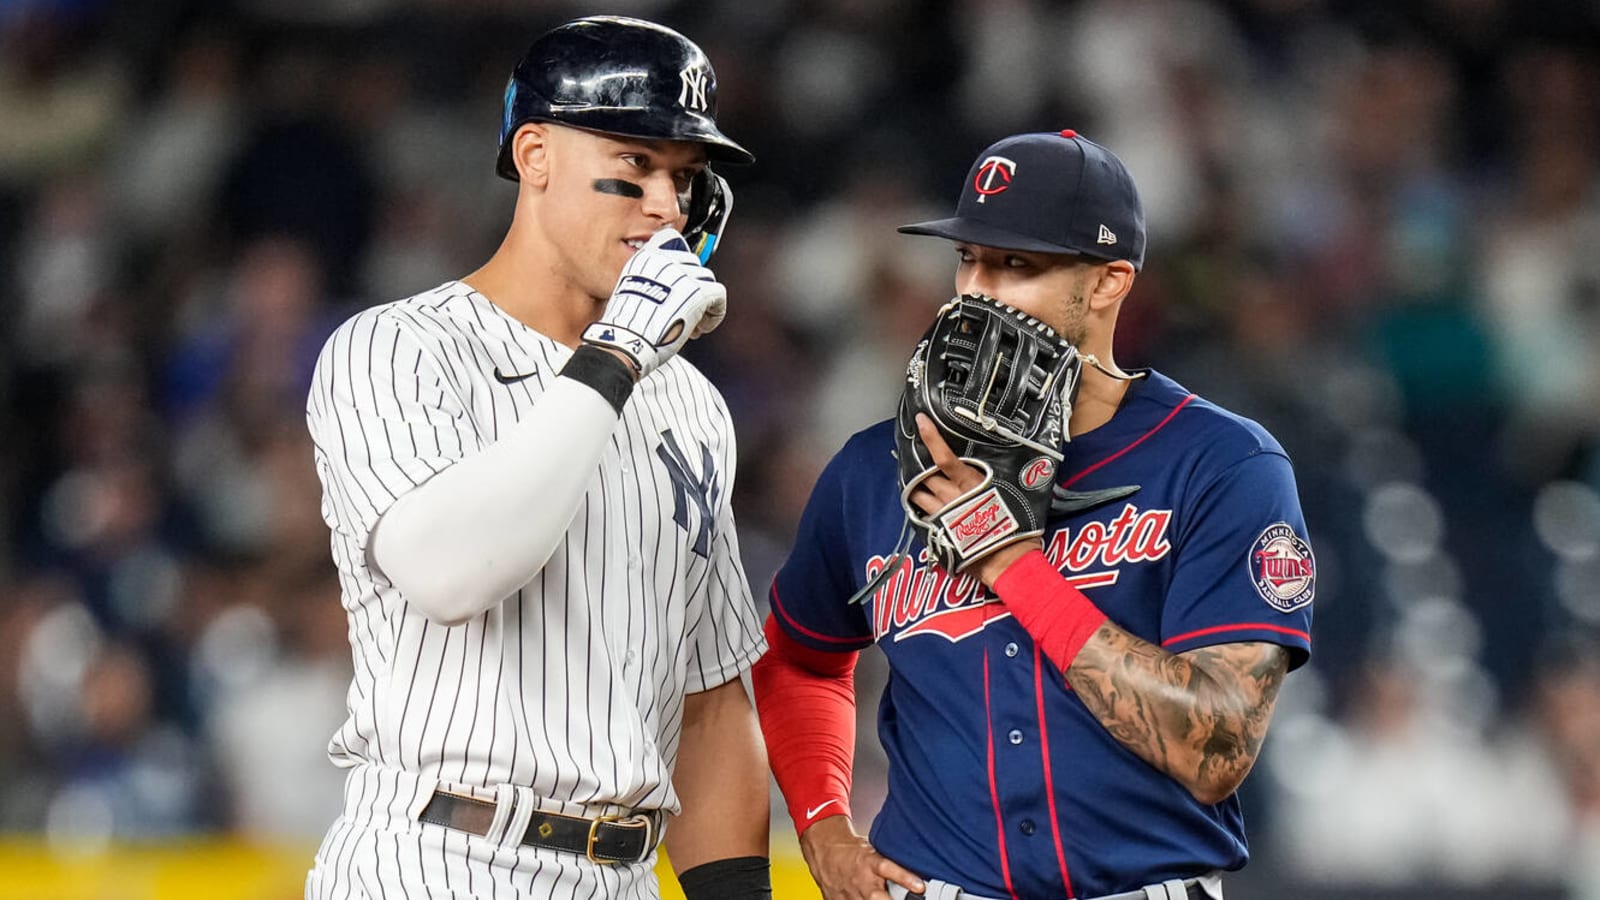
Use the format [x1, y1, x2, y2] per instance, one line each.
[306, 18, 771, 900]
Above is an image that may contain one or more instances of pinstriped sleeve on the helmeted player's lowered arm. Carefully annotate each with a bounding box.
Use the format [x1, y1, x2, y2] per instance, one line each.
[685, 395, 766, 693]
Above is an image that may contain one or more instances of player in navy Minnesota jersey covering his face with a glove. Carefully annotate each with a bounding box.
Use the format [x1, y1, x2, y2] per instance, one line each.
[754, 131, 1315, 900]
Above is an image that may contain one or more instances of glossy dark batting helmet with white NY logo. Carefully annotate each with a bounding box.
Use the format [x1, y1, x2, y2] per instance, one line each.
[494, 16, 755, 181]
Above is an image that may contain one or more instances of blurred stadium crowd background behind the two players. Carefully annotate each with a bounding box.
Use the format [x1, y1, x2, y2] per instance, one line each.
[0, 0, 1600, 900]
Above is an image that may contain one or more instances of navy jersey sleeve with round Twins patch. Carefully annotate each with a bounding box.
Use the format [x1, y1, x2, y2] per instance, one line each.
[1162, 452, 1317, 668]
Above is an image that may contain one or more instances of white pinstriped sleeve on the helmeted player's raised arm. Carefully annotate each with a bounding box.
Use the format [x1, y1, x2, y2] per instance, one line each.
[306, 309, 482, 551]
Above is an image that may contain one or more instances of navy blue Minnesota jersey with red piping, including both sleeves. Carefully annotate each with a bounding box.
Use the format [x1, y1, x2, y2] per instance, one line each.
[771, 372, 1315, 897]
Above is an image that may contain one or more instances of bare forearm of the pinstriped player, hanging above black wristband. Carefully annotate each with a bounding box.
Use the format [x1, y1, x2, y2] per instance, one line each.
[666, 679, 771, 874]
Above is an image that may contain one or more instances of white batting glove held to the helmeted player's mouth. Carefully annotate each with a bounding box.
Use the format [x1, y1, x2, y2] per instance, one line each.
[584, 227, 728, 378]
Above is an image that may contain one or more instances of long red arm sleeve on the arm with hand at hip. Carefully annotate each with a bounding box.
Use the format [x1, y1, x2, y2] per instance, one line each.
[750, 617, 858, 833]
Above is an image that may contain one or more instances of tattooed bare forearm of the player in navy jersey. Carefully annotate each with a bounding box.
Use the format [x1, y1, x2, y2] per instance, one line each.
[1067, 623, 1288, 802]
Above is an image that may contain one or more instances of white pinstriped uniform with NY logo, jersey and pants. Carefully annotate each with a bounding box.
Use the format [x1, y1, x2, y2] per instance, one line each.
[307, 282, 765, 898]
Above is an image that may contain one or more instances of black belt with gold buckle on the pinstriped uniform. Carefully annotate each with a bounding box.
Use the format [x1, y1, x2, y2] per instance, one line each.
[416, 791, 661, 865]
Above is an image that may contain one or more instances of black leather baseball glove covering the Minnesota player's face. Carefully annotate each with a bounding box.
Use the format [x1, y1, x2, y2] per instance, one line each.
[894, 295, 1083, 572]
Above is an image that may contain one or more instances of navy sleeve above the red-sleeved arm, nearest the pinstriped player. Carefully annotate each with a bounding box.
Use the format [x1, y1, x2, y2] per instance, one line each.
[768, 442, 872, 652]
